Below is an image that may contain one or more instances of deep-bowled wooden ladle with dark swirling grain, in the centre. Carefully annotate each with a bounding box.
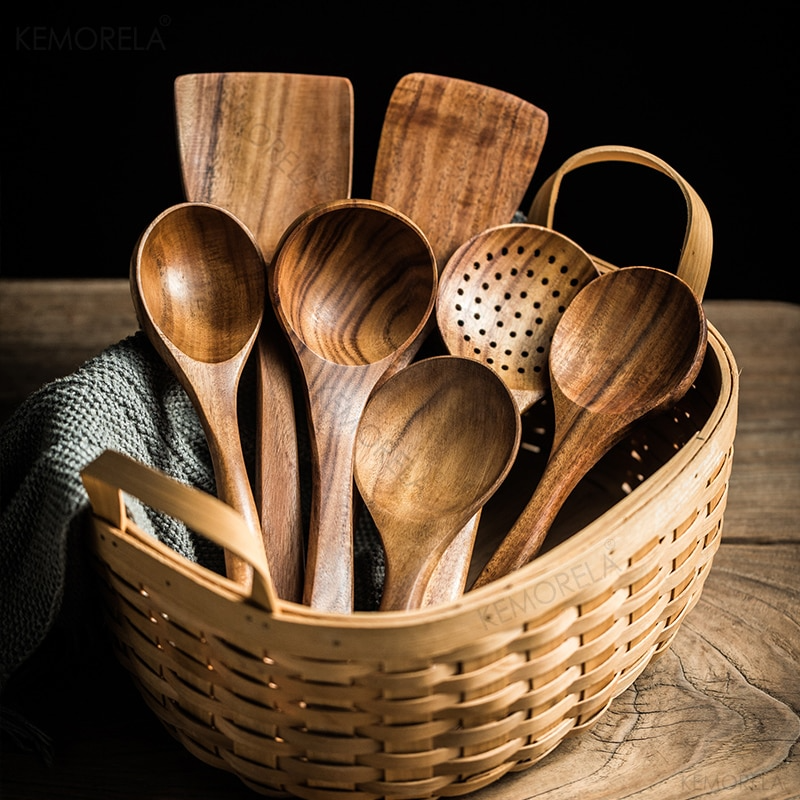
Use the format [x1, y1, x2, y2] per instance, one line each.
[270, 200, 437, 613]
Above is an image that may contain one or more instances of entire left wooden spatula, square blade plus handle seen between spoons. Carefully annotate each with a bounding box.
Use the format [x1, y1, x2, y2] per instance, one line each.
[175, 72, 353, 602]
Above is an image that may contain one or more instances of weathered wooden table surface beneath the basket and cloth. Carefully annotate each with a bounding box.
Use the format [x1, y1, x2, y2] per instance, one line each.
[0, 280, 800, 800]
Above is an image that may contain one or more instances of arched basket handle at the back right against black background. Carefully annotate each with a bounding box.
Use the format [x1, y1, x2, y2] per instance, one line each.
[528, 145, 713, 300]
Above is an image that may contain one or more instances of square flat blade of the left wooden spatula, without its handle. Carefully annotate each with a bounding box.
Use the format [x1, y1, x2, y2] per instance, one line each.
[175, 72, 353, 262]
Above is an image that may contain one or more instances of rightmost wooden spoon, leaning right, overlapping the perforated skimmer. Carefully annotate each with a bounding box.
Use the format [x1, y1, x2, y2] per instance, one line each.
[474, 267, 707, 587]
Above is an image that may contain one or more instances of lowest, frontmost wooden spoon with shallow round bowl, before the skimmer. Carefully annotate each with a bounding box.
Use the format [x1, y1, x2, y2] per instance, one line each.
[355, 356, 522, 611]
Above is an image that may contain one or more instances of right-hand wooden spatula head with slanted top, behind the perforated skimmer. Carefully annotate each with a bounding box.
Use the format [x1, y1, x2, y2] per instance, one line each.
[371, 72, 548, 273]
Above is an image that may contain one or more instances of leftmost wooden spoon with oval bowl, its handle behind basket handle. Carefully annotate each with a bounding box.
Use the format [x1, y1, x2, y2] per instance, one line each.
[131, 203, 277, 608]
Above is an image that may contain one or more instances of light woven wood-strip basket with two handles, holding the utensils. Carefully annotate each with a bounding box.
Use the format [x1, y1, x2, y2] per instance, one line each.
[83, 148, 738, 800]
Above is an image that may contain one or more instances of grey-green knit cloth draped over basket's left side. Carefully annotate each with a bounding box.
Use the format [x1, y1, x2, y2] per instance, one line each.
[0, 331, 383, 688]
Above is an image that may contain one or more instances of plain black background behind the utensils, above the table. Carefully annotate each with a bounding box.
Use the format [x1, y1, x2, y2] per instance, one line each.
[0, 2, 800, 302]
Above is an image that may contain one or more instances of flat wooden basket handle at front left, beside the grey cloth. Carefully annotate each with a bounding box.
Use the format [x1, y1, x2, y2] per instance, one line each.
[81, 450, 278, 613]
